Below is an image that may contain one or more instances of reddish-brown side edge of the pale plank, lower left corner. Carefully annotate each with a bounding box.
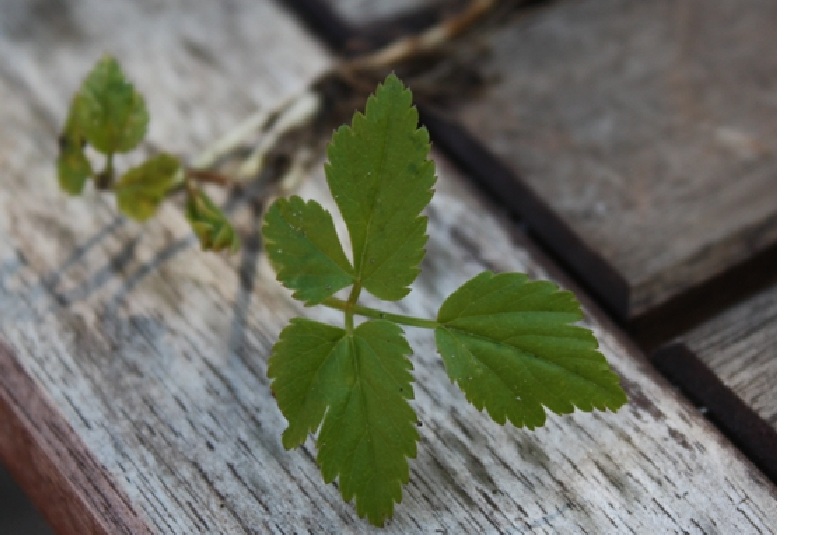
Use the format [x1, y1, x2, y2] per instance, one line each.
[0, 339, 151, 534]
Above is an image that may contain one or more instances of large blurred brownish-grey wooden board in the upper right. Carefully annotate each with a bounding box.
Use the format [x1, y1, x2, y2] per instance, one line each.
[456, 0, 776, 317]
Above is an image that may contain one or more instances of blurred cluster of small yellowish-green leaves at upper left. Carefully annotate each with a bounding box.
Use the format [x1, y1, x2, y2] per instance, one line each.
[57, 56, 239, 251]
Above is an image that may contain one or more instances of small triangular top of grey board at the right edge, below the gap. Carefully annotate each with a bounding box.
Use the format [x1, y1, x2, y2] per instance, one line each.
[680, 286, 777, 428]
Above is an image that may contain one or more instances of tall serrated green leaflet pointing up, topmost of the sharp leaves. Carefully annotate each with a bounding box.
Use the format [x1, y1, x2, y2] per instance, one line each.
[326, 75, 435, 301]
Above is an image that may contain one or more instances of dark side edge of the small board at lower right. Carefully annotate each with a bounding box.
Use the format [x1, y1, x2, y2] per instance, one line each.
[651, 342, 776, 483]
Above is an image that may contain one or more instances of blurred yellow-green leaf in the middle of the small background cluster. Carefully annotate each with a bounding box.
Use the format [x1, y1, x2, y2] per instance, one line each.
[115, 154, 180, 221]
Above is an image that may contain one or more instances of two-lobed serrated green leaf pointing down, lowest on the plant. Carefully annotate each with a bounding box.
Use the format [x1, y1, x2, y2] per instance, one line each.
[268, 318, 418, 526]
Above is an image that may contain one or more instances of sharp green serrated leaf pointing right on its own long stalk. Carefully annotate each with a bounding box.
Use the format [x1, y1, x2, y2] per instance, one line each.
[435, 272, 626, 429]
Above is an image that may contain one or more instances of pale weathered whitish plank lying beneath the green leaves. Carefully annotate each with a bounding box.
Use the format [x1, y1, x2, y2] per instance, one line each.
[0, 0, 776, 533]
